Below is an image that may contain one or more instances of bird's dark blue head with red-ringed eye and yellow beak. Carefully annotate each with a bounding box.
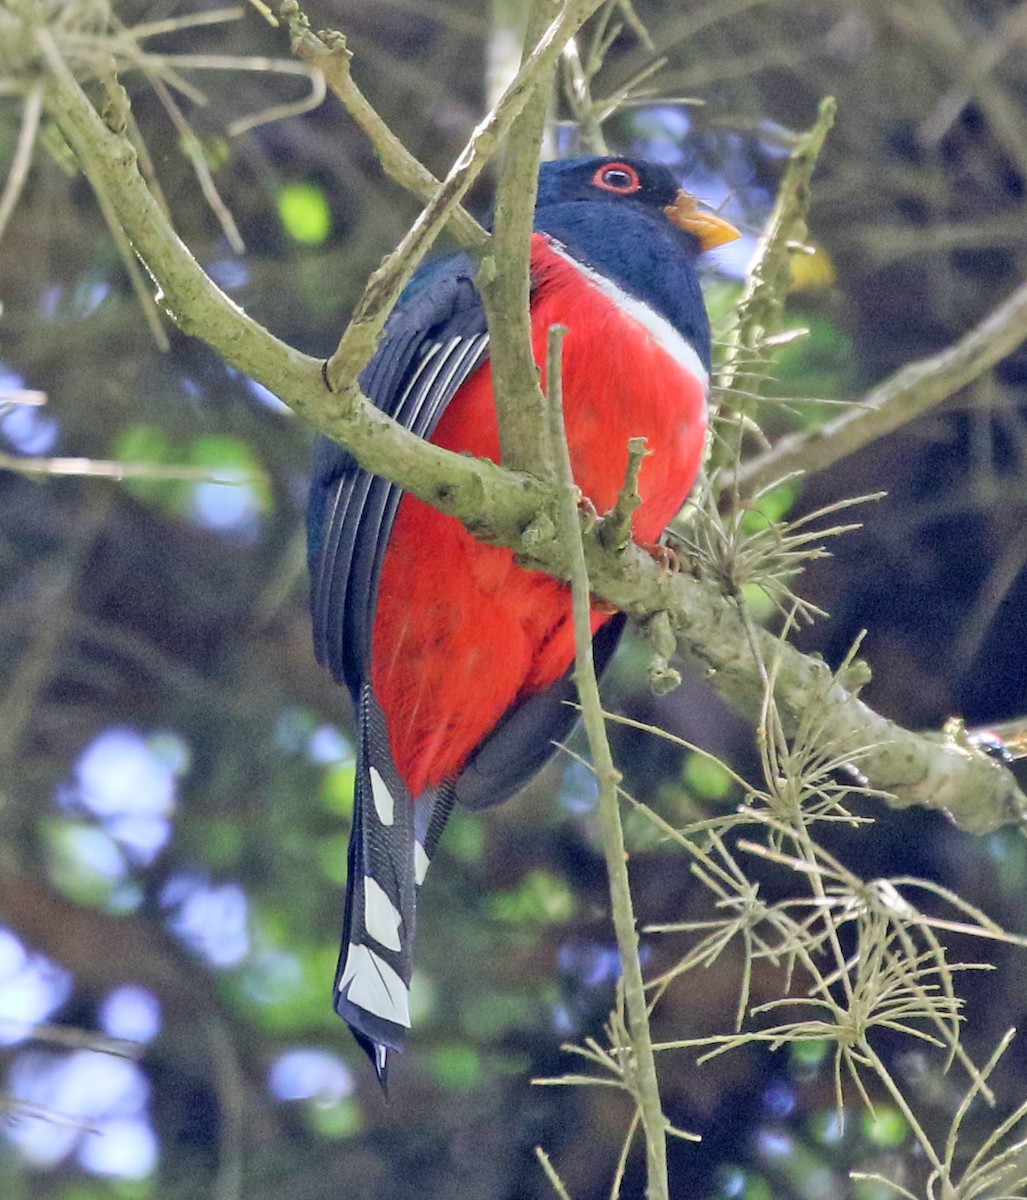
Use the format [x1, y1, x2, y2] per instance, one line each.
[535, 157, 738, 367]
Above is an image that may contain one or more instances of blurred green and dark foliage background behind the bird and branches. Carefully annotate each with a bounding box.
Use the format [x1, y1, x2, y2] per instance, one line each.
[0, 0, 1027, 1200]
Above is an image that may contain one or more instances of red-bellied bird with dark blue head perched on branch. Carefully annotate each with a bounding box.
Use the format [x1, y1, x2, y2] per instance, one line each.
[307, 156, 739, 1094]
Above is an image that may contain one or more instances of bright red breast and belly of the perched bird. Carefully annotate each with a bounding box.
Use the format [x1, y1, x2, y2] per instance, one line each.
[372, 262, 705, 797]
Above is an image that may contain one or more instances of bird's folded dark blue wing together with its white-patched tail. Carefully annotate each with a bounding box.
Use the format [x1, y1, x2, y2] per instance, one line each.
[307, 258, 488, 1086]
